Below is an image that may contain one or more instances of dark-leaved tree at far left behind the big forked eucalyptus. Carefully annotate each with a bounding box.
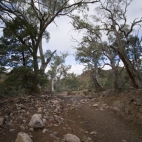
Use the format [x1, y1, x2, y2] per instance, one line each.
[0, 19, 33, 68]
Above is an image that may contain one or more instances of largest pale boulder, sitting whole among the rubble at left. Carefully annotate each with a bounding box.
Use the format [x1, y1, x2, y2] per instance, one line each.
[29, 114, 43, 128]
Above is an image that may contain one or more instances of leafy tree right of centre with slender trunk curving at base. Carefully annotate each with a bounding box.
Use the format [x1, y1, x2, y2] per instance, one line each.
[76, 35, 102, 91]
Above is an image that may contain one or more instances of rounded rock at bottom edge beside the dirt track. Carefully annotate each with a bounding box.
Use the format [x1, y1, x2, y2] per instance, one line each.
[64, 134, 81, 142]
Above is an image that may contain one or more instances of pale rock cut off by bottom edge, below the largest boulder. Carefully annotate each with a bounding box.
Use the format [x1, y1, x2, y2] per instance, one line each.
[15, 132, 33, 142]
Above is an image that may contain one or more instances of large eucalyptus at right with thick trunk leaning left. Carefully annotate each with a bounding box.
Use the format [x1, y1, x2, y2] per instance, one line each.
[72, 0, 142, 88]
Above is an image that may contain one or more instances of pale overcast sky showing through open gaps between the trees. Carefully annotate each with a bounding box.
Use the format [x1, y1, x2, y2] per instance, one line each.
[43, 0, 142, 74]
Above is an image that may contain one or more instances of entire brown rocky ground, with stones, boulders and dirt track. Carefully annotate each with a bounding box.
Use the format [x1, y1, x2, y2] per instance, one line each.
[0, 91, 142, 142]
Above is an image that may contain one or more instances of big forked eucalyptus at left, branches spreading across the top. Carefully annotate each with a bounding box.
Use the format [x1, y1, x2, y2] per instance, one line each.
[0, 0, 99, 75]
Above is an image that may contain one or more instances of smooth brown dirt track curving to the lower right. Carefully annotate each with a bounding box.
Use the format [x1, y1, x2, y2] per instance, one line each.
[61, 97, 142, 142]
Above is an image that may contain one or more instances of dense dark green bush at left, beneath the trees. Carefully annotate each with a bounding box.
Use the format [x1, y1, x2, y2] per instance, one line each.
[0, 67, 47, 95]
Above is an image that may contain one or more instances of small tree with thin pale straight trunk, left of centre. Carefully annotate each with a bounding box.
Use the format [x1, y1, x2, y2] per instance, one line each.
[47, 53, 71, 92]
